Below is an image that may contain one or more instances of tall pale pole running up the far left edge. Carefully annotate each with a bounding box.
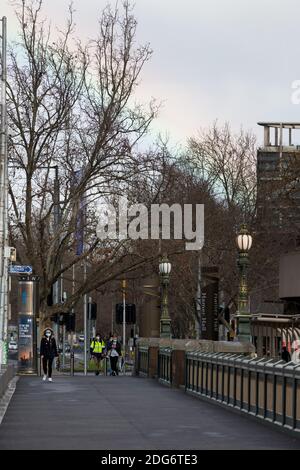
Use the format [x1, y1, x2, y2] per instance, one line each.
[0, 16, 8, 367]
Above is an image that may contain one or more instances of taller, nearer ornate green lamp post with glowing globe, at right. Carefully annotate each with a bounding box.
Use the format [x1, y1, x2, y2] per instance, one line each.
[236, 224, 252, 341]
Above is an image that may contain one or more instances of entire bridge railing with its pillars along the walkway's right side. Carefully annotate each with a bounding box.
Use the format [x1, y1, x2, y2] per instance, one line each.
[135, 338, 300, 434]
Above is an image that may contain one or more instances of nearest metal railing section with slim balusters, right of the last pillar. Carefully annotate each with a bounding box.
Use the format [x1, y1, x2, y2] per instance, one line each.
[185, 351, 300, 432]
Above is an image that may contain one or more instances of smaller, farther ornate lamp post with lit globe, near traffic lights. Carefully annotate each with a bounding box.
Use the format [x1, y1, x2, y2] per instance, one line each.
[159, 255, 171, 338]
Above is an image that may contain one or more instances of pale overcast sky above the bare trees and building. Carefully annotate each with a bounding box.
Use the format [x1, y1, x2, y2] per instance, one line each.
[0, 0, 300, 145]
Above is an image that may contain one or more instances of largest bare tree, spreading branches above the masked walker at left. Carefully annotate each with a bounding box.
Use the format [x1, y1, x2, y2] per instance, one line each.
[8, 0, 166, 324]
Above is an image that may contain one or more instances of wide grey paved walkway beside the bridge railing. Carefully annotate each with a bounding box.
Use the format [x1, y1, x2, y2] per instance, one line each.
[0, 376, 300, 450]
